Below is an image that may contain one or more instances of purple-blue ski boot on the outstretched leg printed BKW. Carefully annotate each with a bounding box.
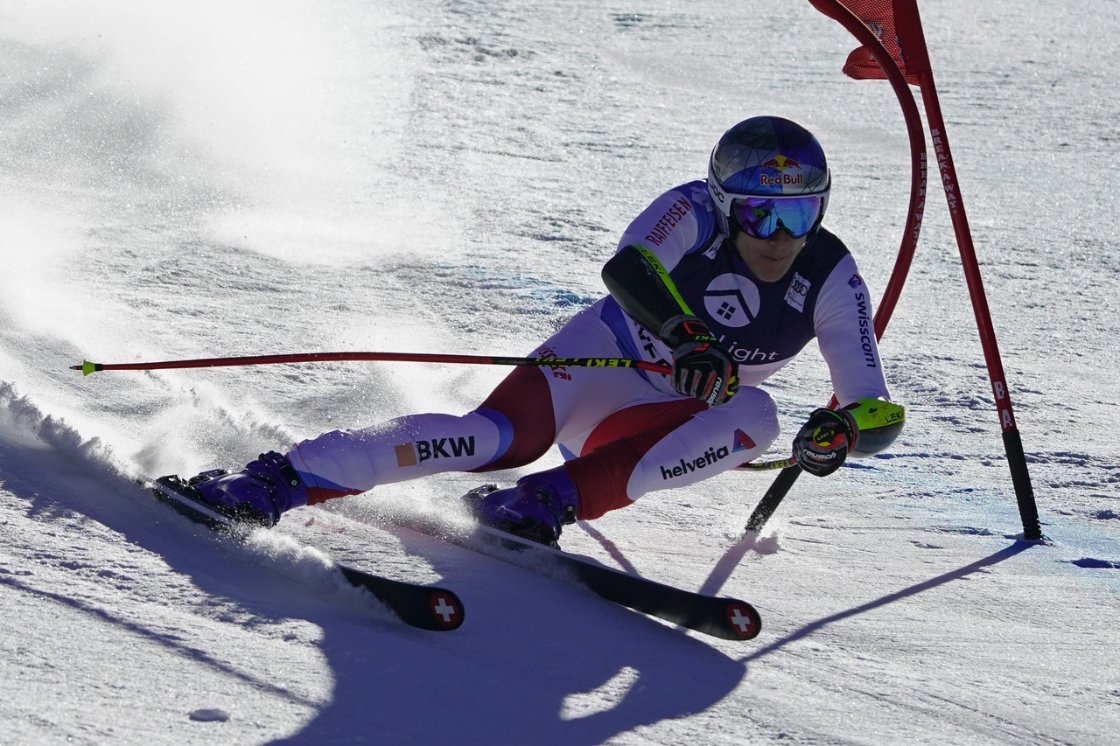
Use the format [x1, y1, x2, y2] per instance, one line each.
[190, 451, 308, 526]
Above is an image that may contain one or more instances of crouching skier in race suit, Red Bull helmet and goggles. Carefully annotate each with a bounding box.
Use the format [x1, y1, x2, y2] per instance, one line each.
[183, 116, 903, 543]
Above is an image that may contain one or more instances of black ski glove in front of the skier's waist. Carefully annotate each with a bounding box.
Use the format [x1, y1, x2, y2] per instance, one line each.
[661, 316, 739, 407]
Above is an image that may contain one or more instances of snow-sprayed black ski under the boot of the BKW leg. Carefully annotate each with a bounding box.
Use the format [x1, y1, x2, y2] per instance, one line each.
[150, 472, 465, 632]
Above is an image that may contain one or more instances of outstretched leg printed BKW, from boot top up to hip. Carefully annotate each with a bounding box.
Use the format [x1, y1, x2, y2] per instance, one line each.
[288, 307, 666, 503]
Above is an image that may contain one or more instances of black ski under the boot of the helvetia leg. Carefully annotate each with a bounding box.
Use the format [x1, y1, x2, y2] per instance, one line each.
[382, 488, 762, 641]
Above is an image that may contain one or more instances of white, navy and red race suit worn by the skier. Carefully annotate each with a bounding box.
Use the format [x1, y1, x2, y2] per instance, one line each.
[289, 181, 888, 519]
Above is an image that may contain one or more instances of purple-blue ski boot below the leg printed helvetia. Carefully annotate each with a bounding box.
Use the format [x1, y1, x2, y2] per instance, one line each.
[467, 466, 579, 547]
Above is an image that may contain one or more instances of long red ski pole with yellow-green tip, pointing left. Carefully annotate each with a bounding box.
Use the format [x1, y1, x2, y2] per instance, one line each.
[71, 352, 673, 375]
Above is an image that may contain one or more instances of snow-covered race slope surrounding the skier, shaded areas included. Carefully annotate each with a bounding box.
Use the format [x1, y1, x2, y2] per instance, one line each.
[0, 0, 1120, 744]
